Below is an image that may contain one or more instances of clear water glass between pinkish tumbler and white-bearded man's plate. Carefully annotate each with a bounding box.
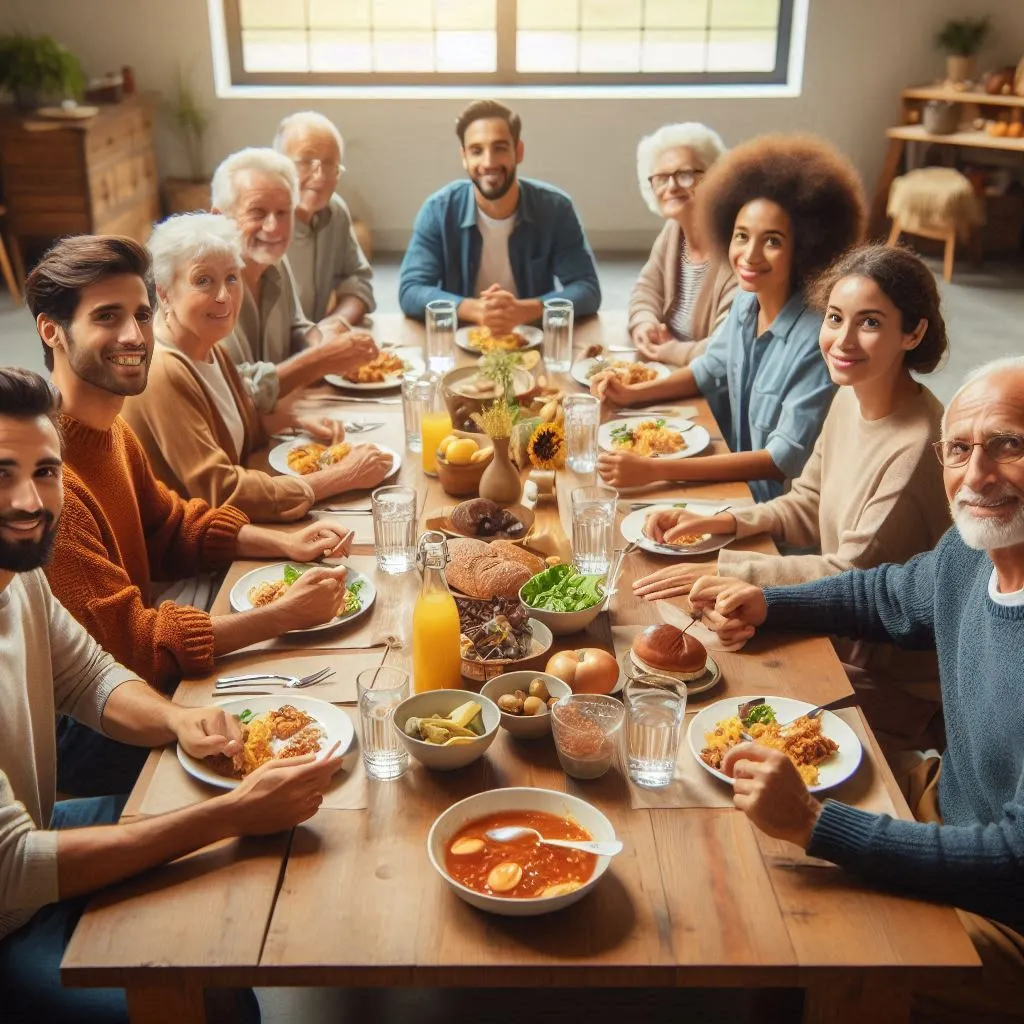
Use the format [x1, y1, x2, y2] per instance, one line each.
[623, 673, 686, 790]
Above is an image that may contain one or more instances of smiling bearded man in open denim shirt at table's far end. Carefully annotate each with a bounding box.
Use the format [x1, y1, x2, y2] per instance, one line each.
[398, 100, 601, 334]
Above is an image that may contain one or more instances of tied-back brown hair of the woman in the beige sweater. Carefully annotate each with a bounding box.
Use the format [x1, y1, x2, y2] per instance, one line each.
[807, 245, 949, 374]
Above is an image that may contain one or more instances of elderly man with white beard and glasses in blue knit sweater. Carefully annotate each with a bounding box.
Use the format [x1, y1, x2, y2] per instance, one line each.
[690, 356, 1024, 1012]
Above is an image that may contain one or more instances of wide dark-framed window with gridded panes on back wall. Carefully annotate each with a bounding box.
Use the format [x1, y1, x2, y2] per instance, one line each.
[222, 0, 795, 86]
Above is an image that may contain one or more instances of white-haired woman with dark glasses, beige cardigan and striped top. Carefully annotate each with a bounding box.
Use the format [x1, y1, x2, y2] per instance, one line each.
[629, 122, 736, 366]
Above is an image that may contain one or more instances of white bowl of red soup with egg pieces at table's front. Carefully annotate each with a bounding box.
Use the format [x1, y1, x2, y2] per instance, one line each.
[427, 786, 615, 918]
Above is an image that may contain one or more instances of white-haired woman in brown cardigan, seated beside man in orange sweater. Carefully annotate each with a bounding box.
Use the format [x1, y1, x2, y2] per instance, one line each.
[122, 213, 391, 522]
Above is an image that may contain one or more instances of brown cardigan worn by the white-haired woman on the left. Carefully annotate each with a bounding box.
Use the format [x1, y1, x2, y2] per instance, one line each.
[121, 344, 315, 522]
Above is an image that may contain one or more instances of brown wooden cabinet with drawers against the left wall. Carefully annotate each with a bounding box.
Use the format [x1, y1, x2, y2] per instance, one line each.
[0, 98, 160, 273]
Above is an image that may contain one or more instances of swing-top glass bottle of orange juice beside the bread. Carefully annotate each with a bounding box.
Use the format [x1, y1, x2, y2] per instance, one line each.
[413, 532, 462, 693]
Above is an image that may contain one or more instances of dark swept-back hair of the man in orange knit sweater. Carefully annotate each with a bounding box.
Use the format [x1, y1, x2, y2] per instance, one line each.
[25, 234, 157, 370]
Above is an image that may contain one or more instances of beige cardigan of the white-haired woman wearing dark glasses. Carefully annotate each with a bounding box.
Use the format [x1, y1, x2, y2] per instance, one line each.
[627, 220, 736, 361]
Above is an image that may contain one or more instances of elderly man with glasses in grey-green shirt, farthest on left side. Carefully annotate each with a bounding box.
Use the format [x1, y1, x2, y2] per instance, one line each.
[273, 111, 376, 324]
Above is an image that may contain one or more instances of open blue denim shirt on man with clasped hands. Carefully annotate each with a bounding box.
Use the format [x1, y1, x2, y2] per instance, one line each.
[398, 178, 601, 319]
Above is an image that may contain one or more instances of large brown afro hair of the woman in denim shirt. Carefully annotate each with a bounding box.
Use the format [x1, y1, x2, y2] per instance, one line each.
[697, 134, 866, 291]
